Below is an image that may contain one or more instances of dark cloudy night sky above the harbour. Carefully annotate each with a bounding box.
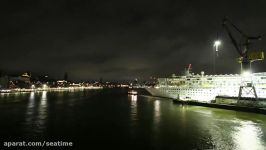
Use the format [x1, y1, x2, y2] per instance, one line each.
[0, 0, 266, 80]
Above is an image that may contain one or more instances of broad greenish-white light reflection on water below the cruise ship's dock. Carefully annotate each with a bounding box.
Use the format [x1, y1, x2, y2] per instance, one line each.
[187, 107, 266, 150]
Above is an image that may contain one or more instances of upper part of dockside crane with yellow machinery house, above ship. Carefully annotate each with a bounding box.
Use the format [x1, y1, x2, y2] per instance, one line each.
[223, 17, 264, 73]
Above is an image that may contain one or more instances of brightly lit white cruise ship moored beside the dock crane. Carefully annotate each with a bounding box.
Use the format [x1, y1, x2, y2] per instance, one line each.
[146, 69, 266, 102]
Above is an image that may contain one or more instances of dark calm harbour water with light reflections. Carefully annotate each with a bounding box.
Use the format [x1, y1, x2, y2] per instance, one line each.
[0, 89, 266, 150]
